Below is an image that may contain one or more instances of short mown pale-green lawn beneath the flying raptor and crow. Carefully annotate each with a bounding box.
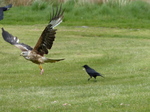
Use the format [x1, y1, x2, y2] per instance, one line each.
[0, 25, 150, 112]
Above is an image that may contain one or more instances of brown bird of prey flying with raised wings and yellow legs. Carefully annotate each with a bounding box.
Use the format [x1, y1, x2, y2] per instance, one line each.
[2, 6, 64, 74]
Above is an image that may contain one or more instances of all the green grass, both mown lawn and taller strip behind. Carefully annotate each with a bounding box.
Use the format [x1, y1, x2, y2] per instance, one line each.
[0, 1, 150, 112]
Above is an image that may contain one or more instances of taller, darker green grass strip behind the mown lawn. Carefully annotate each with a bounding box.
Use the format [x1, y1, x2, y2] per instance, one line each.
[0, 0, 150, 28]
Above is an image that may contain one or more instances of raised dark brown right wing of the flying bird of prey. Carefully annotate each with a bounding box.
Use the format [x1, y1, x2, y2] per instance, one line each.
[34, 6, 64, 56]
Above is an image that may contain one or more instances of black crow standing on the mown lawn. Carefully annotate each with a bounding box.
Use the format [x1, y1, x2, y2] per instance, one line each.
[83, 65, 104, 81]
